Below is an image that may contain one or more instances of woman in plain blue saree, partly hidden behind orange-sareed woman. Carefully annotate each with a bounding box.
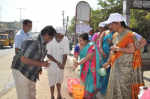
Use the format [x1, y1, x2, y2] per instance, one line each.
[99, 24, 115, 97]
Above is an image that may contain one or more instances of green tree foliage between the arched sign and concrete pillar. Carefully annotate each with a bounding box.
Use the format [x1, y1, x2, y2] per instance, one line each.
[91, 0, 123, 31]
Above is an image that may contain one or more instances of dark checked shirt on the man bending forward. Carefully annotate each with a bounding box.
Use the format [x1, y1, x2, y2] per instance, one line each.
[11, 34, 47, 82]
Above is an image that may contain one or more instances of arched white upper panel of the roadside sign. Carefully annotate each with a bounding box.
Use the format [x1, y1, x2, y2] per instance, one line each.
[76, 1, 91, 21]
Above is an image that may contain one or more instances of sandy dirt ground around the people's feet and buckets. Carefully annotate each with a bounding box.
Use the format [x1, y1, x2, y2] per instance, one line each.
[0, 54, 150, 99]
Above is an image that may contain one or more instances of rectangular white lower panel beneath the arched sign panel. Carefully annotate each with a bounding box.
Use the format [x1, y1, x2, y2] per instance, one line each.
[76, 23, 90, 33]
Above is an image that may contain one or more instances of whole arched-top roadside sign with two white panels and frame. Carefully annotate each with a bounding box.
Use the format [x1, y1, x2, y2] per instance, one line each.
[74, 1, 91, 45]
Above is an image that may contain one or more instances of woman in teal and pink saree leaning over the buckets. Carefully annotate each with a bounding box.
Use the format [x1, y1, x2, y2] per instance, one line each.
[74, 33, 100, 99]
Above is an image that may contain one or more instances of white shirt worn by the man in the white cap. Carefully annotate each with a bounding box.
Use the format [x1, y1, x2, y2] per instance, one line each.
[46, 37, 70, 73]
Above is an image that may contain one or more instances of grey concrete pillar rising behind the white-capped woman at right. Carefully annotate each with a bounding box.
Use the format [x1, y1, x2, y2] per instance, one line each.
[123, 0, 131, 27]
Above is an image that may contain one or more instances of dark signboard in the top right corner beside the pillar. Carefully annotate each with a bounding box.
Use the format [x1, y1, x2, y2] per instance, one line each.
[131, 0, 150, 10]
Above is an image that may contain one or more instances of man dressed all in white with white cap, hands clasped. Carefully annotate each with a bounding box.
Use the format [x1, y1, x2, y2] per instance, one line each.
[47, 28, 70, 99]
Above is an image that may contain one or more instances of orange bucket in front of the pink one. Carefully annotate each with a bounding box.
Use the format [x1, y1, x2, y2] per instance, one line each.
[71, 84, 85, 99]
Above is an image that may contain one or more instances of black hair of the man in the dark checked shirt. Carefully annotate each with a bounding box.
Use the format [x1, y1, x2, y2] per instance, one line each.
[41, 25, 56, 36]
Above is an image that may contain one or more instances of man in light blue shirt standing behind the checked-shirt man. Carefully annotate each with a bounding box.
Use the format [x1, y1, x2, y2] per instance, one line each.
[15, 19, 32, 53]
